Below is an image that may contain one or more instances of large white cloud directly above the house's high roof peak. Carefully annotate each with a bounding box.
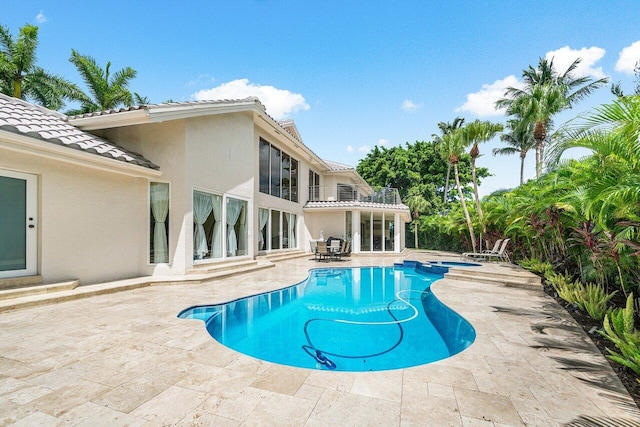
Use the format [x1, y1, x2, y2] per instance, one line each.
[192, 79, 311, 120]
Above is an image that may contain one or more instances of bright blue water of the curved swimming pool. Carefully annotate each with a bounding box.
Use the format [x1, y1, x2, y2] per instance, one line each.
[179, 261, 475, 371]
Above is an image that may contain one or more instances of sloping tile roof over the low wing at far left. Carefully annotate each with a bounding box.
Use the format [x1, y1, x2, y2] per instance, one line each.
[0, 94, 160, 169]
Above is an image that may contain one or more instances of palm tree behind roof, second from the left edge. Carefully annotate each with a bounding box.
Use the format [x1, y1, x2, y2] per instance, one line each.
[67, 49, 136, 115]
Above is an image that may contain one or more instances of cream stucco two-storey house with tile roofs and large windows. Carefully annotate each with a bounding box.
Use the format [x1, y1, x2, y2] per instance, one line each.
[0, 95, 410, 283]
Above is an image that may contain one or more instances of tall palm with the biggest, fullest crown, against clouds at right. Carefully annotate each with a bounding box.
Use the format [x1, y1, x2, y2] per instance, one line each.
[496, 58, 609, 178]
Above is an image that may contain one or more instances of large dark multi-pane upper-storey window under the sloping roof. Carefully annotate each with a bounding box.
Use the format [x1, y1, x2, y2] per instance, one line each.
[258, 139, 298, 203]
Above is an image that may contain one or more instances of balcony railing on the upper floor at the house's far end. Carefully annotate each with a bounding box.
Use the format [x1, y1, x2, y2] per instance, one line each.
[309, 184, 402, 205]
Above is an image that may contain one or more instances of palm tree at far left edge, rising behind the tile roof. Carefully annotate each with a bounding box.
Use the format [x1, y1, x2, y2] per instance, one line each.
[0, 24, 80, 110]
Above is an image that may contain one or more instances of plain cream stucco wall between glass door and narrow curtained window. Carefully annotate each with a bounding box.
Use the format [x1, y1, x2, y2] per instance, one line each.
[0, 148, 147, 283]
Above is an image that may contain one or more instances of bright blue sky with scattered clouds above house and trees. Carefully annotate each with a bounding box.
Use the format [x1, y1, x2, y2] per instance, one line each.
[5, 0, 640, 194]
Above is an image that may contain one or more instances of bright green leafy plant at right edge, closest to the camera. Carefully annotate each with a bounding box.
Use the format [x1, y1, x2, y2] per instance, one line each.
[600, 294, 640, 382]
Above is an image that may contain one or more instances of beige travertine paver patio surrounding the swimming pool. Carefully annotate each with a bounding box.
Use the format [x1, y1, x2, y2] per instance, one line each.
[0, 251, 640, 426]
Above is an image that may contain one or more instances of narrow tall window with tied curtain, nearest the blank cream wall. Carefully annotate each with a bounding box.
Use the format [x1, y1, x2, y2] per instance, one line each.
[149, 182, 169, 264]
